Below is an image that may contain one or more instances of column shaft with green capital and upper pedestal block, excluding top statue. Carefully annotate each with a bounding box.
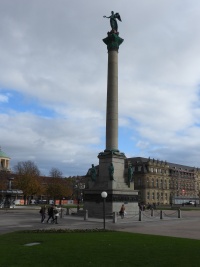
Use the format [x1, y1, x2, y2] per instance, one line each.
[91, 31, 126, 189]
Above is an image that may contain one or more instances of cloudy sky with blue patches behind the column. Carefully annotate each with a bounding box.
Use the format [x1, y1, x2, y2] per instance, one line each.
[0, 0, 200, 176]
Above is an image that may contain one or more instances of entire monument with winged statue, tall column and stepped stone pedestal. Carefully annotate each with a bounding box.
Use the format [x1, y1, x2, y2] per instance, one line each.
[84, 17, 138, 217]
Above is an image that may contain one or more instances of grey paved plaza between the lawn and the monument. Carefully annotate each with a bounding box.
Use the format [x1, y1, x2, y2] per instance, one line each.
[0, 209, 200, 239]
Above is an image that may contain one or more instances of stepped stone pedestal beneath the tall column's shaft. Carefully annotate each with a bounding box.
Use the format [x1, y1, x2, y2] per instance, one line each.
[84, 152, 138, 218]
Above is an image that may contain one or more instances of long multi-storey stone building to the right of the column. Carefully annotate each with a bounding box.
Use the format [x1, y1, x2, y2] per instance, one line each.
[127, 157, 200, 204]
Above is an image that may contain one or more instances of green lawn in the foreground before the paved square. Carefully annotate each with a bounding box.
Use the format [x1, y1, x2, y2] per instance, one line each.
[0, 232, 200, 267]
